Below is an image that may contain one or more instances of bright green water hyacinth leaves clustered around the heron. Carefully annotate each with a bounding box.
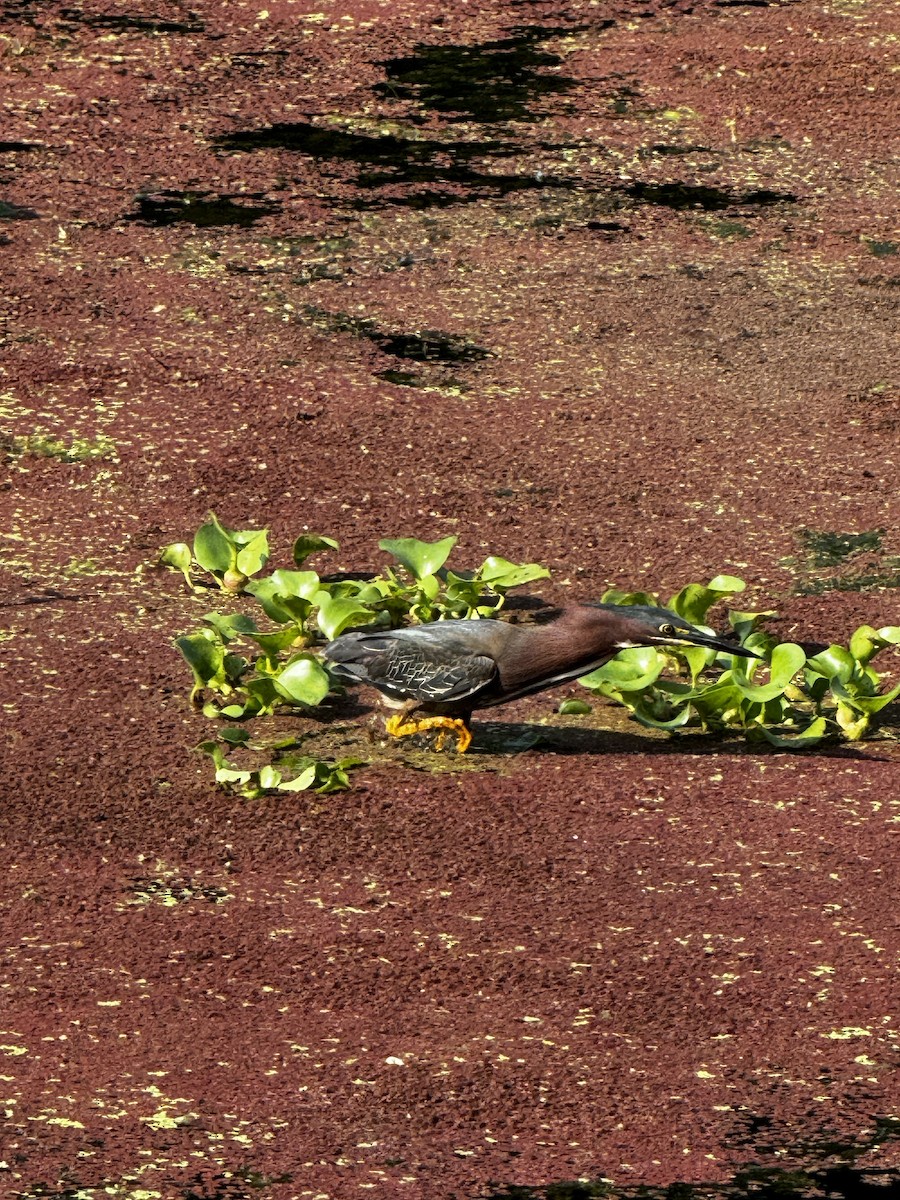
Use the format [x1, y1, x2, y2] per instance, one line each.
[160, 516, 900, 796]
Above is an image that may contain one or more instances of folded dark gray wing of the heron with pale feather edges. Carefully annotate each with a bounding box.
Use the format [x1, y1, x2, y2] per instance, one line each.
[323, 622, 497, 703]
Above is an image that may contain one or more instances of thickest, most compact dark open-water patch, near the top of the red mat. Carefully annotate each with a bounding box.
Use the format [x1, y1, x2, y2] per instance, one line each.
[372, 20, 585, 125]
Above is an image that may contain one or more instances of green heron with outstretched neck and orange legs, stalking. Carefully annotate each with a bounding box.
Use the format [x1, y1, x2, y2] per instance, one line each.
[323, 604, 757, 752]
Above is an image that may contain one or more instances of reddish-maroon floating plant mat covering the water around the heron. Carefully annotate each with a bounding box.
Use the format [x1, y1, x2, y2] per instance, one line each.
[0, 0, 900, 1200]
